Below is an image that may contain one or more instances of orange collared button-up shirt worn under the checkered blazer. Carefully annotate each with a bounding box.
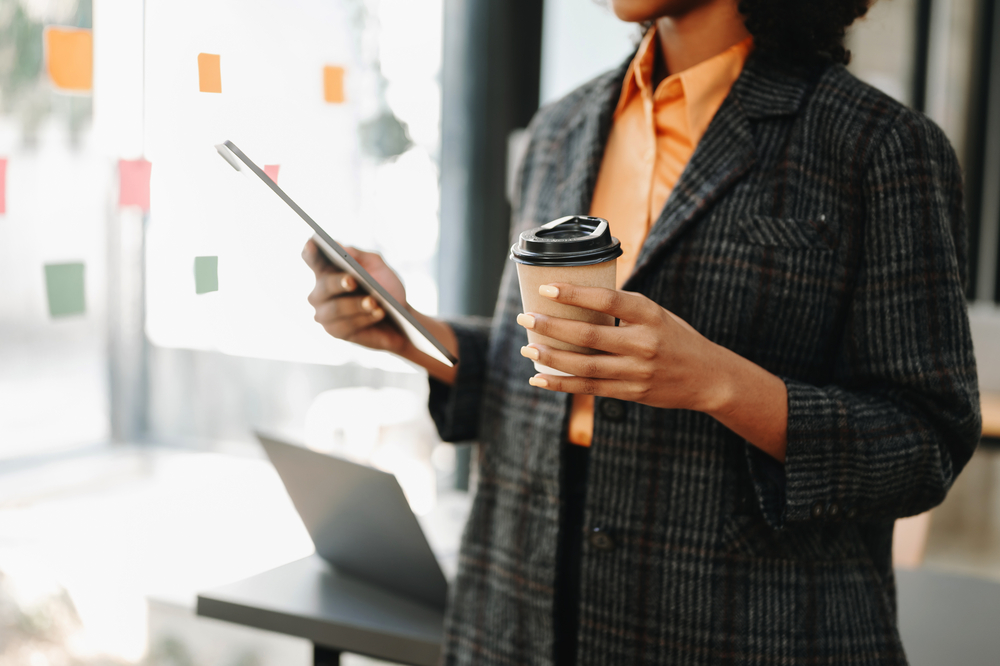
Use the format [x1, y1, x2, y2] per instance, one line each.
[569, 28, 753, 446]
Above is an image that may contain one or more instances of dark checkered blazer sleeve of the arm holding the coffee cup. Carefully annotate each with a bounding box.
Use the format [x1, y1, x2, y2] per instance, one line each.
[747, 113, 982, 528]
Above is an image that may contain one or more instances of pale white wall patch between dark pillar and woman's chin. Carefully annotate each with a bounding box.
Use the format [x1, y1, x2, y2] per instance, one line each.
[541, 0, 640, 104]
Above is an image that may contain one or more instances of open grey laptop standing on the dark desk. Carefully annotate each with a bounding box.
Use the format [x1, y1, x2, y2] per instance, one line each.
[256, 432, 448, 611]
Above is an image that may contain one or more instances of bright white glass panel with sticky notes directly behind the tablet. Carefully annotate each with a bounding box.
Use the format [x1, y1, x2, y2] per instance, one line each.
[145, 0, 441, 372]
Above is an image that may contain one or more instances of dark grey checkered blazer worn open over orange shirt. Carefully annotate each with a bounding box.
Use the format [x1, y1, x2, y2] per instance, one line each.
[430, 56, 980, 666]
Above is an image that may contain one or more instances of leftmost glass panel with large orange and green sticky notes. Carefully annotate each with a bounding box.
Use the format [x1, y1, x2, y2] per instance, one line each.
[0, 0, 113, 459]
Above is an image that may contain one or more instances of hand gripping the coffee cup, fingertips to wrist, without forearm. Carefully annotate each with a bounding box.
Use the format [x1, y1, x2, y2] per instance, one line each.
[517, 283, 732, 413]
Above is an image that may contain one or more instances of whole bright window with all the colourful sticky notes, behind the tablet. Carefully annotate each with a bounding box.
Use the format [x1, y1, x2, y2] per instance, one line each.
[0, 0, 450, 472]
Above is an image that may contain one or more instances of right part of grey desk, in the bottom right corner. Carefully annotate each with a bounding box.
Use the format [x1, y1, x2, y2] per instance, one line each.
[896, 569, 1000, 666]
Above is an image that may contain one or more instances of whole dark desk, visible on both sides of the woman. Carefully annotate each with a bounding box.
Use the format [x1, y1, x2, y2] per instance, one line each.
[198, 555, 1000, 666]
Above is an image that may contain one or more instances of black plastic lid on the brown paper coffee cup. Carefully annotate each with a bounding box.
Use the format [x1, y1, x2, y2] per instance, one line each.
[510, 215, 622, 266]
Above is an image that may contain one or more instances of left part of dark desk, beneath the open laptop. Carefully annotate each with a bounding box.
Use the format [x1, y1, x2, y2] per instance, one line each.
[197, 555, 444, 666]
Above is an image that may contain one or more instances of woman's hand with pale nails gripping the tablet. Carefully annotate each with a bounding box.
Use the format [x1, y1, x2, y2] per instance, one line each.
[302, 239, 410, 354]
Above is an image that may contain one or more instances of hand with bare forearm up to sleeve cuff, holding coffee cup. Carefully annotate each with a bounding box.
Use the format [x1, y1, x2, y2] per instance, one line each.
[517, 283, 788, 462]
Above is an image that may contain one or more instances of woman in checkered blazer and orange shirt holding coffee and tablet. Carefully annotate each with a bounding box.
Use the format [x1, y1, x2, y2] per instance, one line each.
[304, 0, 980, 664]
